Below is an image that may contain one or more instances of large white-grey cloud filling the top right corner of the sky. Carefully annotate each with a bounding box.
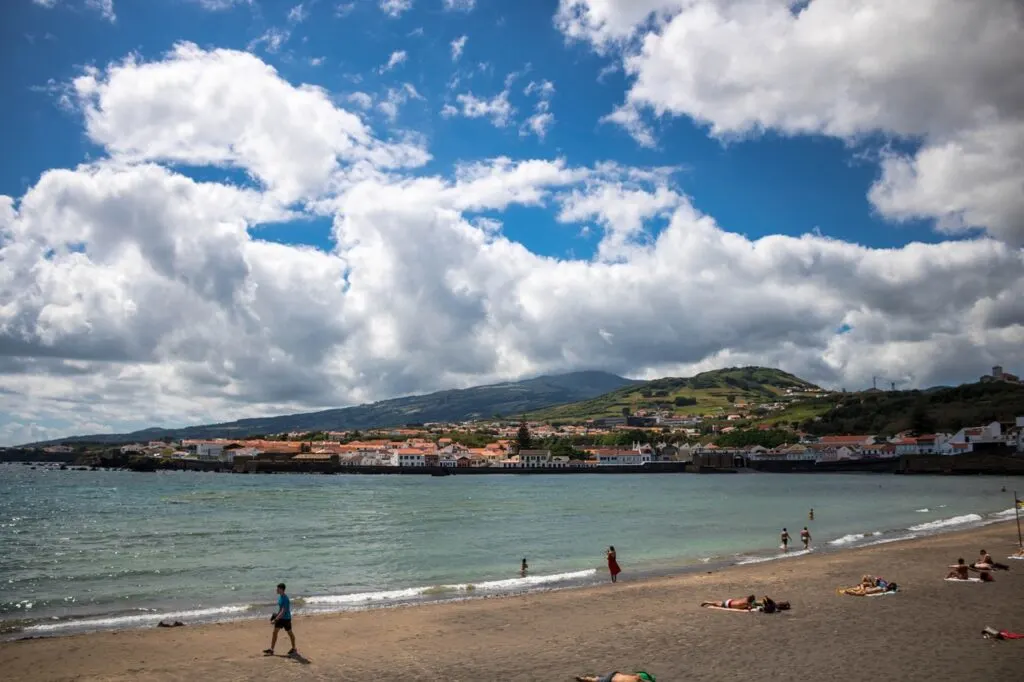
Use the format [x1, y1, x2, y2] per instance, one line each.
[556, 0, 1024, 245]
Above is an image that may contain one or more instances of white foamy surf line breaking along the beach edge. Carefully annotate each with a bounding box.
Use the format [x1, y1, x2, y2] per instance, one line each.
[0, 509, 1024, 644]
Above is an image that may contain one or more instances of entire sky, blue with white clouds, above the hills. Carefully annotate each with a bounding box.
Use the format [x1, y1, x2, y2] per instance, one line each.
[0, 0, 1024, 445]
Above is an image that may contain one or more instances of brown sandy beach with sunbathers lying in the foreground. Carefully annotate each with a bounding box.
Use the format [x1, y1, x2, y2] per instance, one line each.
[0, 523, 1024, 682]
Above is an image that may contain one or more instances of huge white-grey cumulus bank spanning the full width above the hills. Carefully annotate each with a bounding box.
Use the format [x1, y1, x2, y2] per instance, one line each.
[0, 44, 1024, 442]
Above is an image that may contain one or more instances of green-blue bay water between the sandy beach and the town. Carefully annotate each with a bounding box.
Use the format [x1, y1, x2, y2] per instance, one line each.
[0, 465, 1014, 639]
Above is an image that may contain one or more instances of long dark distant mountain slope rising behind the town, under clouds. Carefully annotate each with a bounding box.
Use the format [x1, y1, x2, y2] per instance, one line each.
[33, 372, 638, 445]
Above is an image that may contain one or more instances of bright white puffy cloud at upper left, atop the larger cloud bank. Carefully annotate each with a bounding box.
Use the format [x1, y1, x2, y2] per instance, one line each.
[74, 43, 427, 203]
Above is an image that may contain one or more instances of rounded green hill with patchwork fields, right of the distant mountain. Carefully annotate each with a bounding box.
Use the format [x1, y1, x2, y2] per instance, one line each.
[527, 367, 821, 421]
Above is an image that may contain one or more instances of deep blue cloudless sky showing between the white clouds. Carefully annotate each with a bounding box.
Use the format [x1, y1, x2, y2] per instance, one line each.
[0, 0, 937, 257]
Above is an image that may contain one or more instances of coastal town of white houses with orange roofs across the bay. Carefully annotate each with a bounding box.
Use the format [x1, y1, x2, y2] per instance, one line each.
[34, 417, 1024, 471]
